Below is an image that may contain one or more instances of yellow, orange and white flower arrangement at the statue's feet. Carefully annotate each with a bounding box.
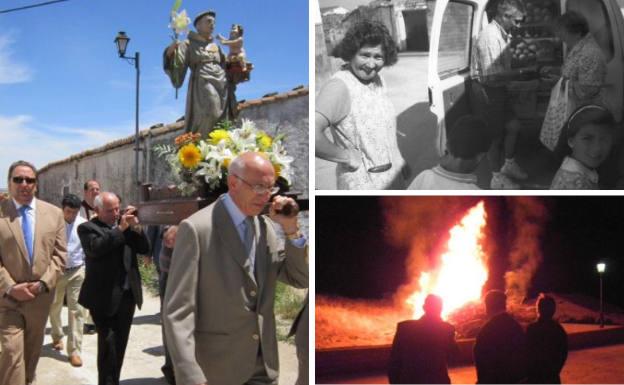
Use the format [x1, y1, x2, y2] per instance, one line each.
[154, 119, 294, 196]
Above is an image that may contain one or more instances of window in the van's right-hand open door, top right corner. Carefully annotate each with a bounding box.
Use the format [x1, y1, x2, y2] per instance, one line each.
[567, 0, 613, 62]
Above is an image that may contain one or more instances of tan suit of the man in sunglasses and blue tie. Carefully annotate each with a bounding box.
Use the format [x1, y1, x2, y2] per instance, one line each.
[0, 199, 67, 385]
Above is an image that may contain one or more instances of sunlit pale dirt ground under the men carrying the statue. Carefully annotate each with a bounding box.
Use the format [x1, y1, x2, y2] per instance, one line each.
[37, 292, 297, 385]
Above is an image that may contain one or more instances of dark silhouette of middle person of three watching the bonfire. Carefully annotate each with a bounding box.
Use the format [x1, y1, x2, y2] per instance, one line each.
[474, 290, 526, 384]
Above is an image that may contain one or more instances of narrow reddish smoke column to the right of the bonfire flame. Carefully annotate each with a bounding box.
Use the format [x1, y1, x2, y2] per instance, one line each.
[505, 197, 548, 305]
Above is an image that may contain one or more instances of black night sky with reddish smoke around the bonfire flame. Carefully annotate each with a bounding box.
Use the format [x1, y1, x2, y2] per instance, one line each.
[316, 196, 624, 306]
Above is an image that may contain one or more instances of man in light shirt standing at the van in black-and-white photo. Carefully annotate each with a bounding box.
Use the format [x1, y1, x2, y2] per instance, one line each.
[471, 0, 527, 188]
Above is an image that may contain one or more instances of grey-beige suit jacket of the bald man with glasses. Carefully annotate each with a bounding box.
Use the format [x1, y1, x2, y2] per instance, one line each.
[164, 199, 308, 385]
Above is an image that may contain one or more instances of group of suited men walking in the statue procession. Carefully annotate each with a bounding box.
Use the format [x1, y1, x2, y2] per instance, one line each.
[0, 152, 308, 385]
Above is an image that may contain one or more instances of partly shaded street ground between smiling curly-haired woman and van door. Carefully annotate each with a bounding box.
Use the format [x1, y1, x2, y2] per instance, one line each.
[315, 53, 438, 190]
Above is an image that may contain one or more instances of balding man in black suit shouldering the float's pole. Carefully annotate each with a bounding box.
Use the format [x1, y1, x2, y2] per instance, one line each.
[78, 192, 149, 385]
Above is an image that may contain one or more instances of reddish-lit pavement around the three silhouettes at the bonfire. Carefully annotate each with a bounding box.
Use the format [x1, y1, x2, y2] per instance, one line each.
[320, 345, 624, 384]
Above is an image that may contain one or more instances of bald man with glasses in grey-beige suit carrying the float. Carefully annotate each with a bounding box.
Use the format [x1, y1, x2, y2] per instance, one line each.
[164, 152, 308, 385]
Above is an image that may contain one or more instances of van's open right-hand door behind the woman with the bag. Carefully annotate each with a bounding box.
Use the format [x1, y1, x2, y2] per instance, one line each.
[561, 0, 624, 122]
